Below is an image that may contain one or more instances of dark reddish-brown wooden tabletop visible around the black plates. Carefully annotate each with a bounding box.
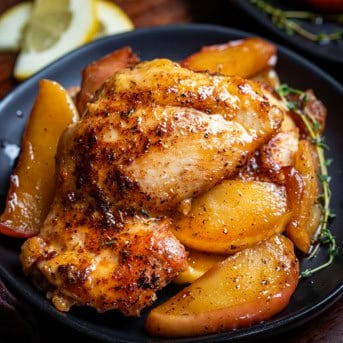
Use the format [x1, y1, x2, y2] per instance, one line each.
[0, 0, 343, 343]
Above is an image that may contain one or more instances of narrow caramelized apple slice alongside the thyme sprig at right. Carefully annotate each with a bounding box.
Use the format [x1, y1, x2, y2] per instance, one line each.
[285, 140, 320, 253]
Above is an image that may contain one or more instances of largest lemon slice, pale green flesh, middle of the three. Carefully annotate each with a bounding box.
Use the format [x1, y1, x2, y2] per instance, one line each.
[14, 0, 98, 80]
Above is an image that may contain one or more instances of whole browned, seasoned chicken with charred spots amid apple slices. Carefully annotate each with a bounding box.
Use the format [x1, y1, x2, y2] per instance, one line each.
[21, 59, 283, 315]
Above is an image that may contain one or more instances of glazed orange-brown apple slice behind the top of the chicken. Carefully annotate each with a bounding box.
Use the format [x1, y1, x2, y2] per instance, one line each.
[181, 37, 277, 78]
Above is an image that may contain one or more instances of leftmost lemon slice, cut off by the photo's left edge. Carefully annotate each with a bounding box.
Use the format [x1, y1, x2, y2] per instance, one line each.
[0, 2, 32, 50]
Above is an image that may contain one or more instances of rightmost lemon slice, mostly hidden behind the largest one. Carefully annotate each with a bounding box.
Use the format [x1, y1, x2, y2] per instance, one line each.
[96, 0, 134, 38]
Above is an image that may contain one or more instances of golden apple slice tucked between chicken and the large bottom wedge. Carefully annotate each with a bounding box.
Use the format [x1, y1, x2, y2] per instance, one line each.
[173, 180, 290, 254]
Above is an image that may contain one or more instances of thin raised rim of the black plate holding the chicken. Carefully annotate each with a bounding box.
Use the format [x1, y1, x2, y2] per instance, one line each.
[0, 24, 343, 342]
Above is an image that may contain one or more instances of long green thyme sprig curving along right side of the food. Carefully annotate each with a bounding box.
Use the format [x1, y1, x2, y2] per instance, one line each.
[275, 84, 338, 277]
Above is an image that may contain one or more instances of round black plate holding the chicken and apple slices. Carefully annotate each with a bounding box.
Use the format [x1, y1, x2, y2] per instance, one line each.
[0, 25, 343, 342]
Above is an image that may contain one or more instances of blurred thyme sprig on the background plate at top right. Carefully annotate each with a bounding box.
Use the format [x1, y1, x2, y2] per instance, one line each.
[250, 0, 343, 43]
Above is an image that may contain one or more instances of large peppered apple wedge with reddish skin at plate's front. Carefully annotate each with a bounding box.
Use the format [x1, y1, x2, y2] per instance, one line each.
[145, 235, 299, 337]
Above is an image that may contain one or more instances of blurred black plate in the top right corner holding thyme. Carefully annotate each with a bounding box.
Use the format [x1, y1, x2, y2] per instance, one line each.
[235, 0, 343, 63]
